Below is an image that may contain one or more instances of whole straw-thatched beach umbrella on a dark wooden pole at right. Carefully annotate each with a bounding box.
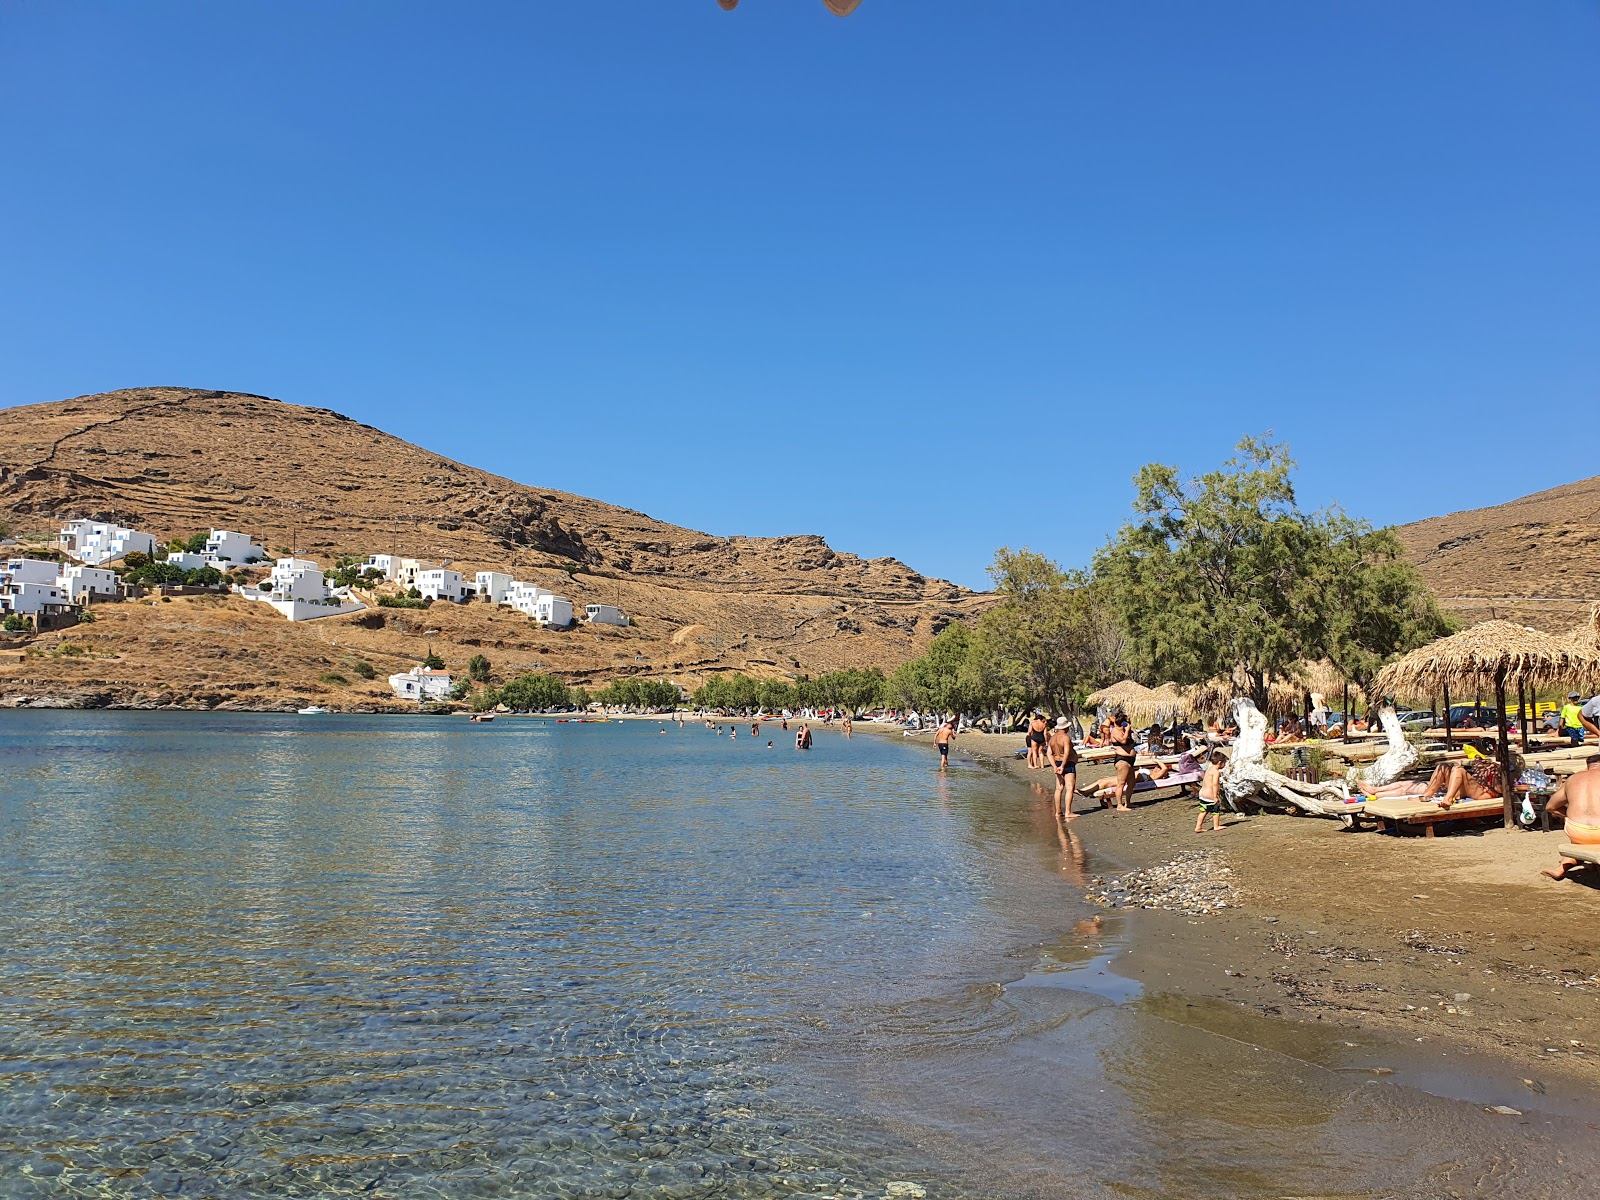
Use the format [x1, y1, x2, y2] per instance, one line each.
[1373, 621, 1576, 829]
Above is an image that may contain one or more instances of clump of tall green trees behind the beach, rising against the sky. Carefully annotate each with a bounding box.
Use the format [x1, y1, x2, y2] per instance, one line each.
[890, 438, 1451, 723]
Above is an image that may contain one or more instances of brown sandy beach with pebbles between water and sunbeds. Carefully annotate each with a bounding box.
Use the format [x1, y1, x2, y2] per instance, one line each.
[934, 726, 1600, 1118]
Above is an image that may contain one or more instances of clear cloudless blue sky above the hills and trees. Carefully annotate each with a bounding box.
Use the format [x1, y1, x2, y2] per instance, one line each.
[0, 0, 1600, 586]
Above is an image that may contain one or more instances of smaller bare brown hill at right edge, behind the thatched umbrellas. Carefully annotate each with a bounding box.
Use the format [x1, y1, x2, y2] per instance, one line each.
[1395, 475, 1600, 630]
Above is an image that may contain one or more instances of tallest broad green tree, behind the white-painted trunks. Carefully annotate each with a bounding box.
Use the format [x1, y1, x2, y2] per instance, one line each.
[1094, 437, 1442, 709]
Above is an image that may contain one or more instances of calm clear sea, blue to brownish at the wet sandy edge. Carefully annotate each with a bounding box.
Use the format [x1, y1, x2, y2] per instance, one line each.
[0, 712, 1600, 1198]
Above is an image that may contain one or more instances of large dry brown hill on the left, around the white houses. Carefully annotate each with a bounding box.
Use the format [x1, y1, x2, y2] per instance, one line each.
[0, 387, 984, 704]
